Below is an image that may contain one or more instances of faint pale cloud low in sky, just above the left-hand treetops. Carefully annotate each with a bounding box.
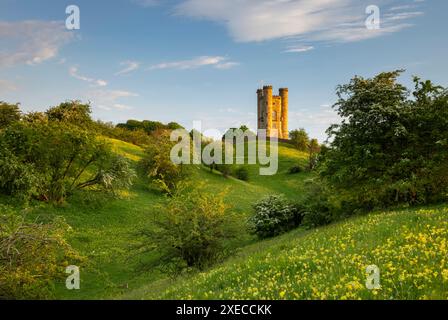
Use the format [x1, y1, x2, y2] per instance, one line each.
[86, 89, 138, 111]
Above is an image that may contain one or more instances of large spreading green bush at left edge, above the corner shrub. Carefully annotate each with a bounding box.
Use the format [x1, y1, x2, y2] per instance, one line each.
[0, 121, 134, 203]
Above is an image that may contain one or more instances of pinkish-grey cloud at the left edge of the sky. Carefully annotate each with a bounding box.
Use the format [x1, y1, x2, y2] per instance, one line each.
[0, 21, 73, 68]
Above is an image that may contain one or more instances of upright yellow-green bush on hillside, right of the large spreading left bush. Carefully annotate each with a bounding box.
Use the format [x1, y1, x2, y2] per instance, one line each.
[139, 133, 190, 195]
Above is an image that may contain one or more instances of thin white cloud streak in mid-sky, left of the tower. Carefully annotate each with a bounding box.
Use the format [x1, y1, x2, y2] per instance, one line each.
[148, 56, 238, 70]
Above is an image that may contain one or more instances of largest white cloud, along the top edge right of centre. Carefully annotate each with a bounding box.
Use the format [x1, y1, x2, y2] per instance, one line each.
[175, 0, 424, 43]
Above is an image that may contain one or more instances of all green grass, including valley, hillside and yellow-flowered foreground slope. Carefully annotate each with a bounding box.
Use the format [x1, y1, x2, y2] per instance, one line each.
[4, 140, 448, 299]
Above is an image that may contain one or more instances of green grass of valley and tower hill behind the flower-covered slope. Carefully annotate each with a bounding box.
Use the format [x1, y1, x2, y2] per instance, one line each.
[23, 139, 309, 299]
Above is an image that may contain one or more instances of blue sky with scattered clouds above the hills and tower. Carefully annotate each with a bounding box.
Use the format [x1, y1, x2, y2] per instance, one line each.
[0, 0, 448, 141]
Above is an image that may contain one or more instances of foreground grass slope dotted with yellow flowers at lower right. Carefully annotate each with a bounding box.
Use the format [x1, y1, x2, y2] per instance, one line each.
[125, 206, 448, 299]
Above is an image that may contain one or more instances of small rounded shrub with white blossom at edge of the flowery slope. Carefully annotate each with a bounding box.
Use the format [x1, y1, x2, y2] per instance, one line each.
[249, 195, 303, 238]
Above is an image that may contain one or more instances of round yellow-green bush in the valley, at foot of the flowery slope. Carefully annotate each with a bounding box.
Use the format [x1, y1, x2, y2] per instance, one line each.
[136, 190, 240, 273]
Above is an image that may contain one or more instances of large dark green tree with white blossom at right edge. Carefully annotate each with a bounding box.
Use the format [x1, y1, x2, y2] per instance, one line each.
[320, 71, 448, 210]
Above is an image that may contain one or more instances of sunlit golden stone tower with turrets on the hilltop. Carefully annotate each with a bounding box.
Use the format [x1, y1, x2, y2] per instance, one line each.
[257, 86, 289, 139]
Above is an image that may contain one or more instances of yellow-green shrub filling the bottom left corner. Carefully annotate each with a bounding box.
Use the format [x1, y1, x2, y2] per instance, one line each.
[0, 206, 83, 300]
